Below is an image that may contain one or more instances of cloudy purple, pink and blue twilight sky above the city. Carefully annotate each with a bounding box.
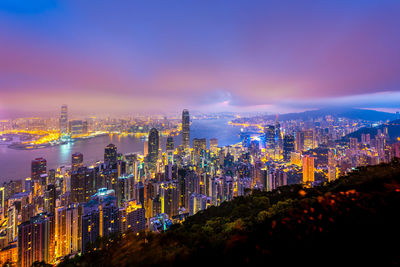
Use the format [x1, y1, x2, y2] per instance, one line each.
[0, 0, 400, 117]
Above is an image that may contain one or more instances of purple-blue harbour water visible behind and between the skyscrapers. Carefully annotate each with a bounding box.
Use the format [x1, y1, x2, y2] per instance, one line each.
[0, 119, 240, 183]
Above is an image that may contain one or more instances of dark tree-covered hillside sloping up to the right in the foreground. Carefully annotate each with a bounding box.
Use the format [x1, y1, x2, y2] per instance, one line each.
[60, 160, 400, 266]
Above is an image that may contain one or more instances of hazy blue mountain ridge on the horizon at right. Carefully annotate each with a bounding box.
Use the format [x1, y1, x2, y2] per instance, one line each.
[234, 107, 397, 122]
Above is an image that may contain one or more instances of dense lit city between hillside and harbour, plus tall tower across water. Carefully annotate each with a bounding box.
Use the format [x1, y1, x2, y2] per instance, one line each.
[0, 106, 400, 267]
